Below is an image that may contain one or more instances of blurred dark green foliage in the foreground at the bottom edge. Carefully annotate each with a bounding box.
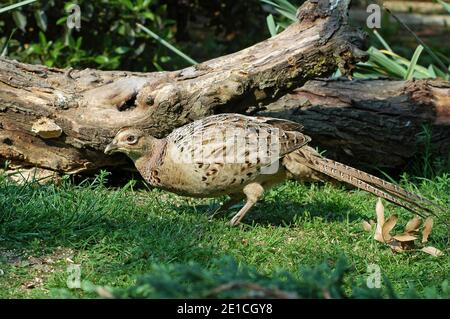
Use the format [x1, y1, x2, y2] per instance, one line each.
[108, 257, 352, 298]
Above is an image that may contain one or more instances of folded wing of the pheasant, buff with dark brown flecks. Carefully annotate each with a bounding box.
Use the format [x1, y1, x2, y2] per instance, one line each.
[167, 114, 310, 166]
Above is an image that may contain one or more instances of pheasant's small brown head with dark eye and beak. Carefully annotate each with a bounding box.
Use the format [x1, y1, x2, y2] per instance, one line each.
[105, 127, 156, 161]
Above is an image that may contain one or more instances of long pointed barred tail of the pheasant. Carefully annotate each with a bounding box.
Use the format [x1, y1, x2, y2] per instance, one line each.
[292, 149, 449, 224]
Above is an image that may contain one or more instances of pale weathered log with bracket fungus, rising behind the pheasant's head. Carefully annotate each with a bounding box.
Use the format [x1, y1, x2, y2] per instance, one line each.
[0, 0, 366, 173]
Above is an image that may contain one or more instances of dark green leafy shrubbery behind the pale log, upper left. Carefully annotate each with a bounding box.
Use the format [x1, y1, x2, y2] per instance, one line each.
[0, 0, 265, 71]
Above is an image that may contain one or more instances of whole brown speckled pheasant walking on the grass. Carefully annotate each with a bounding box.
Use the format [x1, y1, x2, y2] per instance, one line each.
[105, 114, 443, 226]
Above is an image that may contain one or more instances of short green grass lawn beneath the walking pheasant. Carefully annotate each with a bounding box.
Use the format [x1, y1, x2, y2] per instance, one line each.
[0, 171, 450, 298]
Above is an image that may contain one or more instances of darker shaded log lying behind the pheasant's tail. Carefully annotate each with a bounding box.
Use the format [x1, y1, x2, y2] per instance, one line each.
[261, 80, 450, 168]
